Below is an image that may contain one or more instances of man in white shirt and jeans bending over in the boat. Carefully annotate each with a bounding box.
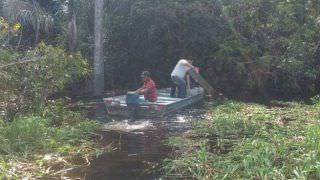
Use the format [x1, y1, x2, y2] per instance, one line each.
[170, 57, 194, 98]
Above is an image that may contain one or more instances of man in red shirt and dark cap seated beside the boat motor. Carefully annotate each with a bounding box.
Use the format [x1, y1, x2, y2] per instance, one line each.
[137, 71, 158, 102]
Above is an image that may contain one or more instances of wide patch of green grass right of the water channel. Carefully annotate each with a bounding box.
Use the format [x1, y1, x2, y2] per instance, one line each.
[163, 101, 320, 179]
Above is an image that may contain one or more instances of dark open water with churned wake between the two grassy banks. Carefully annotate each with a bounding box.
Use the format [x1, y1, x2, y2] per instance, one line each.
[71, 101, 206, 180]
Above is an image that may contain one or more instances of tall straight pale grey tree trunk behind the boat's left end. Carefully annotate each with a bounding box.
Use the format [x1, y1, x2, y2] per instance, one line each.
[93, 0, 104, 96]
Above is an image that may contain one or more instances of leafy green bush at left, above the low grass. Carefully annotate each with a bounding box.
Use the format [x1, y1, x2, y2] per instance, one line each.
[0, 43, 89, 119]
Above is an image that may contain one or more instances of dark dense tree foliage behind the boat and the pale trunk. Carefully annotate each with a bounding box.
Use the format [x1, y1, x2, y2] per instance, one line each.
[1, 0, 320, 98]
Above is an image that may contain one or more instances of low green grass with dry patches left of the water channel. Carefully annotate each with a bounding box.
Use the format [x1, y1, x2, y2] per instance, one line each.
[0, 104, 105, 179]
